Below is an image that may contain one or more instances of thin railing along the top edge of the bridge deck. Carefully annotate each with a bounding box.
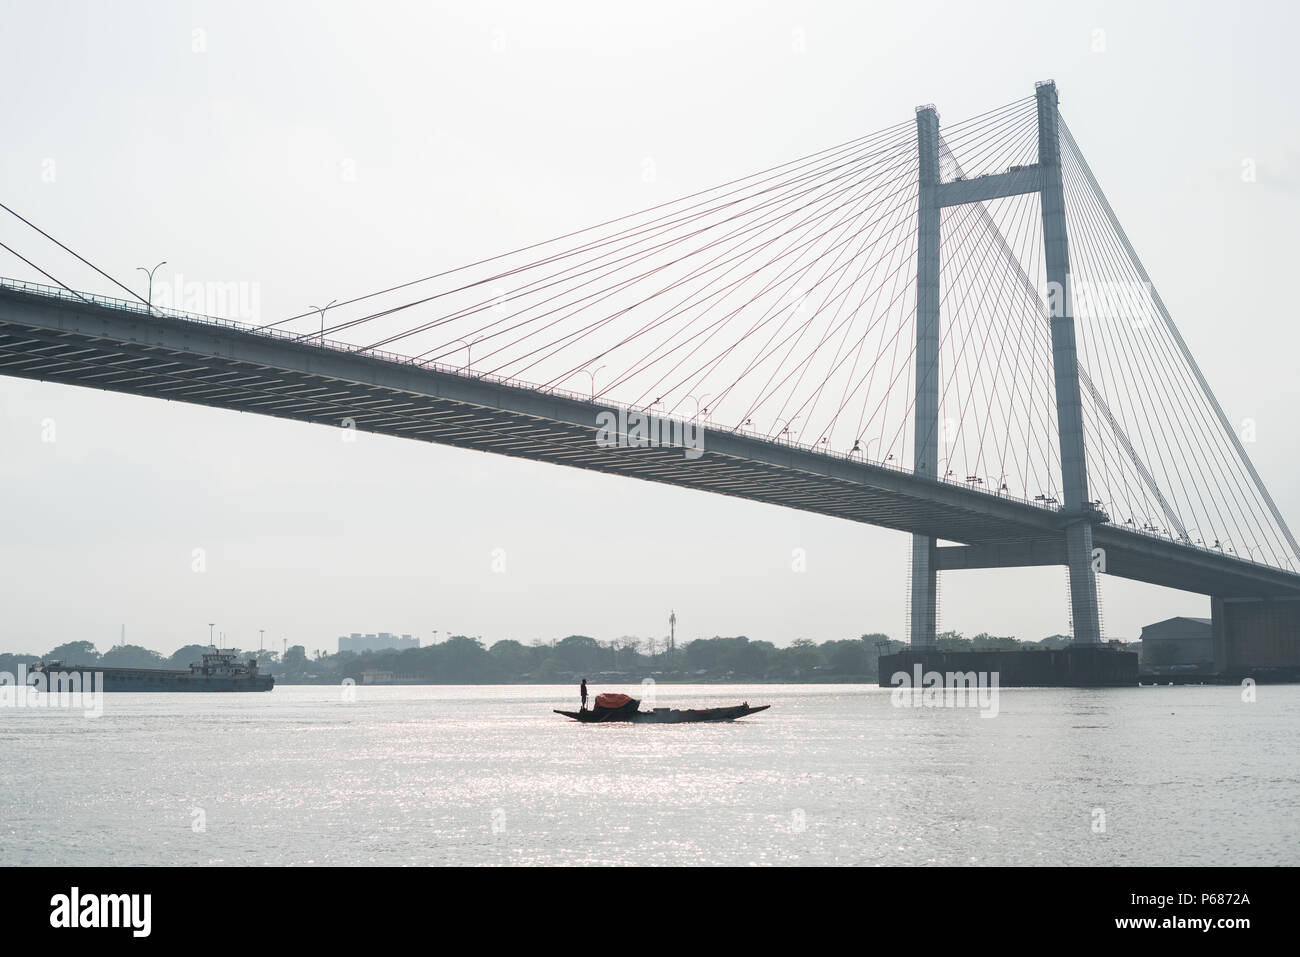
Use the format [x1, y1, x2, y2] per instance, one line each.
[0, 277, 1274, 568]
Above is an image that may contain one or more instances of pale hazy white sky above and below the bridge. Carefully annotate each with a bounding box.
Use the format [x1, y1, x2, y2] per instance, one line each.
[0, 0, 1300, 653]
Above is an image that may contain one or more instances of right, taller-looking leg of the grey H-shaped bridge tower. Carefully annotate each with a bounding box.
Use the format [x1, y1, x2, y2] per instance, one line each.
[1035, 81, 1101, 644]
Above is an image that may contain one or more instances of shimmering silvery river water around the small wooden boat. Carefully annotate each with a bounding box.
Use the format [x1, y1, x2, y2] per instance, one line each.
[0, 685, 1300, 865]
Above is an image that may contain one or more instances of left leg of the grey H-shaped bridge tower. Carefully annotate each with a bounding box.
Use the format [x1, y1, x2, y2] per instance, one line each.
[907, 107, 940, 648]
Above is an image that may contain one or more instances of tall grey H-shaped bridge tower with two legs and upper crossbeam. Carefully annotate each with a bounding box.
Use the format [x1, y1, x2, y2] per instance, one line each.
[909, 81, 1102, 648]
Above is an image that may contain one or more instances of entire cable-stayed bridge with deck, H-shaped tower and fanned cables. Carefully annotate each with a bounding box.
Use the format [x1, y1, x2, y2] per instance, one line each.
[0, 83, 1300, 654]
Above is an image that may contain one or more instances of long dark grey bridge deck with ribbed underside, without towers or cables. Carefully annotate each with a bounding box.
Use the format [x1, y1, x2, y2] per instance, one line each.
[0, 289, 1300, 597]
